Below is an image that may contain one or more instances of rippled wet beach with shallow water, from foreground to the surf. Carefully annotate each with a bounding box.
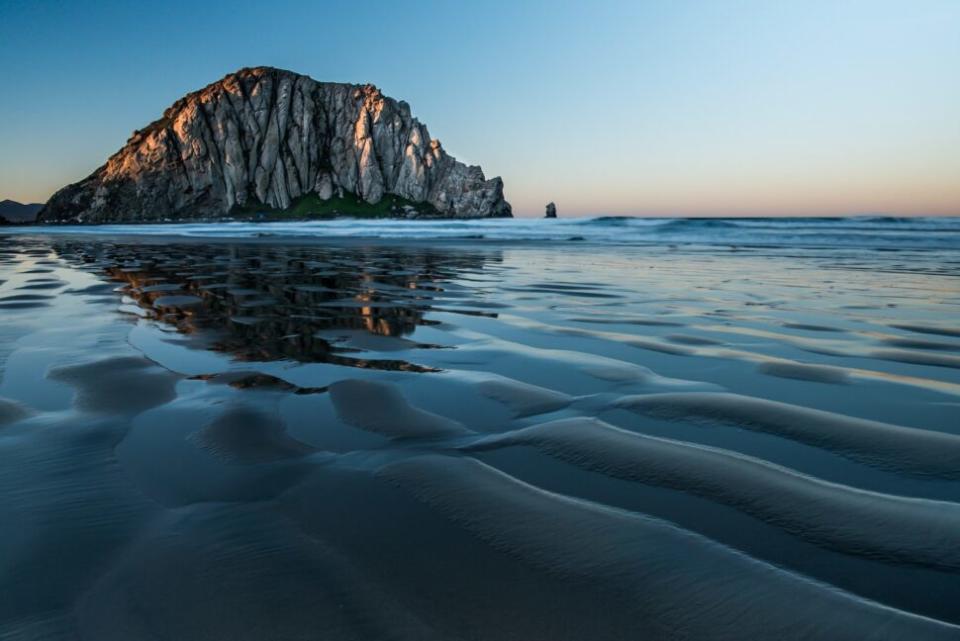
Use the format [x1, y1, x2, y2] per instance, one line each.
[0, 234, 960, 640]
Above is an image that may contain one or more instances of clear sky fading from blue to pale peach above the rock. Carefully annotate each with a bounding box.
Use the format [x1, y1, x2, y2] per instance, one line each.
[0, 0, 960, 216]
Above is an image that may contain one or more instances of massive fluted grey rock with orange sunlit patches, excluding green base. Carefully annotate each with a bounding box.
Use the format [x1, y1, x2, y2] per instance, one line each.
[38, 67, 511, 223]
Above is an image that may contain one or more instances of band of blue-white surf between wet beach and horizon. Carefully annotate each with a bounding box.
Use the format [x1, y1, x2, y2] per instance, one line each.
[3, 216, 960, 250]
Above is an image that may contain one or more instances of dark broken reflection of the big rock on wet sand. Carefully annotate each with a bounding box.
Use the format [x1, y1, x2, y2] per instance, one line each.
[51, 243, 496, 372]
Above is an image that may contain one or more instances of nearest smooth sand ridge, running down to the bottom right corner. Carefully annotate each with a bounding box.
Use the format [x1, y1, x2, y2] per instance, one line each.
[380, 456, 960, 641]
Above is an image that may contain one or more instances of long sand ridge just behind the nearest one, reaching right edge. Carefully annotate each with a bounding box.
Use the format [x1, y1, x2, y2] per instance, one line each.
[470, 418, 960, 571]
